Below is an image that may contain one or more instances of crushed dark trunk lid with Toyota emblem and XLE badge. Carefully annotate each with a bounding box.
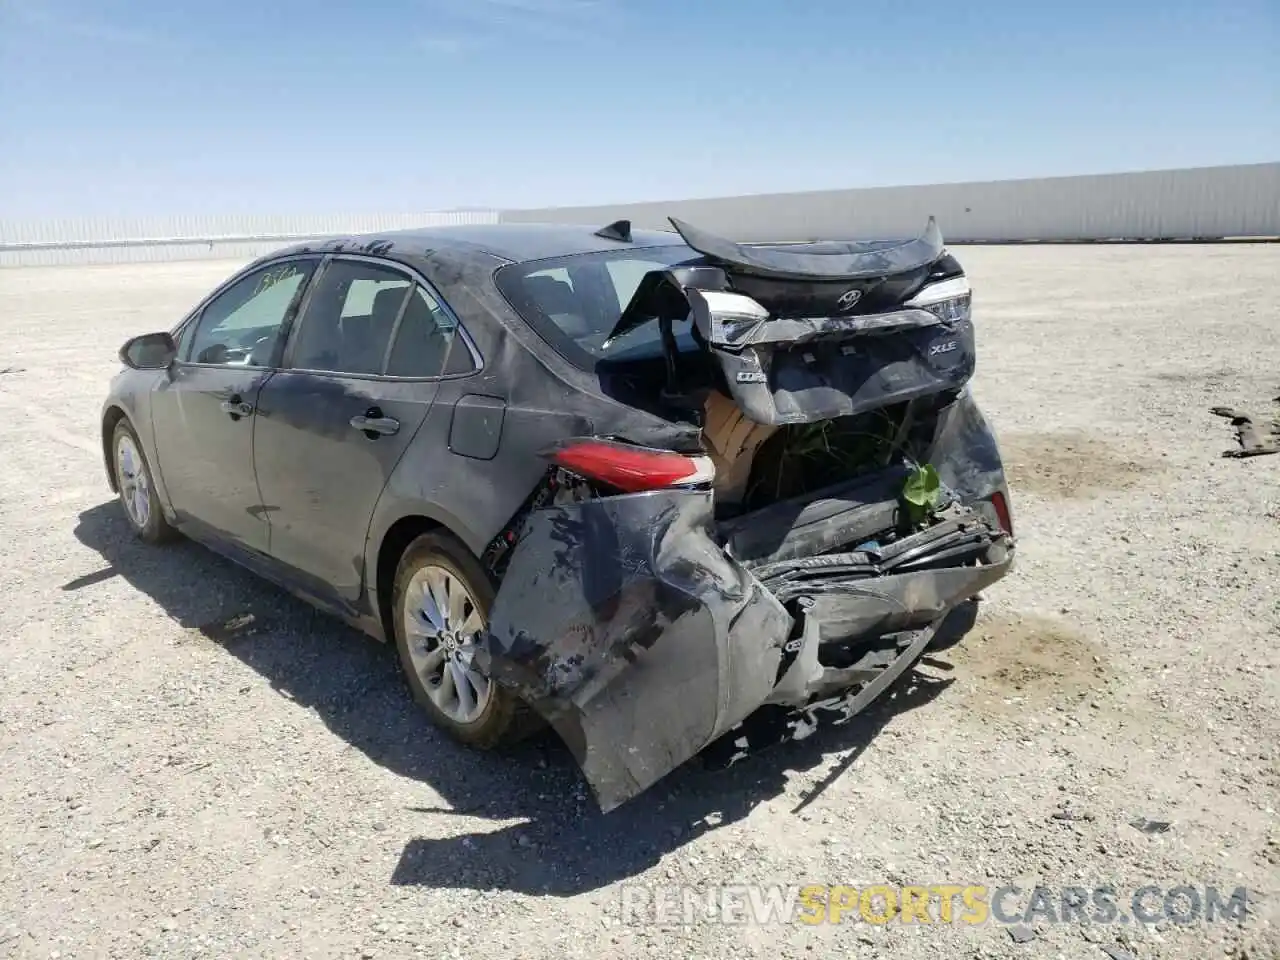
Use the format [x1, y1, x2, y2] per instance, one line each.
[599, 218, 974, 425]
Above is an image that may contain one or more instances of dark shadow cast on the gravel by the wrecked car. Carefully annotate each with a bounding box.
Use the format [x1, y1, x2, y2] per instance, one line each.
[74, 502, 974, 896]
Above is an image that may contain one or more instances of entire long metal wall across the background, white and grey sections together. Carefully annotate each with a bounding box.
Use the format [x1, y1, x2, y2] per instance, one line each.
[0, 163, 1280, 266]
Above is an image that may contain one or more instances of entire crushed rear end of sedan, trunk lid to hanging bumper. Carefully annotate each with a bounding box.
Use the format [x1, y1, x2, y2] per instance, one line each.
[477, 221, 1012, 810]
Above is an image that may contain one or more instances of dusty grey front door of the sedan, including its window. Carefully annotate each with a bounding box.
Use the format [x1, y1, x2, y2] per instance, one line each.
[151, 257, 317, 553]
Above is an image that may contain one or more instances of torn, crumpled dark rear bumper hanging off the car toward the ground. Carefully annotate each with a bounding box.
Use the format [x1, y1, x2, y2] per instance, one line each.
[477, 481, 1011, 812]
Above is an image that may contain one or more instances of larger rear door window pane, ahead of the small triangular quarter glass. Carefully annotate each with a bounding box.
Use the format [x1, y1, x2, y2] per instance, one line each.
[289, 260, 413, 374]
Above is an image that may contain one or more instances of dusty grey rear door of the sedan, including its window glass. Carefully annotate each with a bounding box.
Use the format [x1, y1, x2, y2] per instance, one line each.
[253, 256, 471, 609]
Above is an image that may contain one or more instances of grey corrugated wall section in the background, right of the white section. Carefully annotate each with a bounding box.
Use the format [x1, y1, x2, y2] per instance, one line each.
[502, 163, 1280, 242]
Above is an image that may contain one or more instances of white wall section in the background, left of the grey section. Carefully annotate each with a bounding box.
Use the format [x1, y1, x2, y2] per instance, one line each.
[0, 210, 498, 266]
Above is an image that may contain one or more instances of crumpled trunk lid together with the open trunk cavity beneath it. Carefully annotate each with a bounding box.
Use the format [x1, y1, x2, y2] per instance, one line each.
[598, 220, 973, 535]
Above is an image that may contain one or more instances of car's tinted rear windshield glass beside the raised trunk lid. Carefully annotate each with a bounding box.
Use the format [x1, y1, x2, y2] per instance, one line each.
[494, 244, 698, 370]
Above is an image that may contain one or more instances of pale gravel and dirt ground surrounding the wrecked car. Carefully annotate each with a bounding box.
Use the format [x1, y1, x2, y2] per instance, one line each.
[0, 246, 1280, 960]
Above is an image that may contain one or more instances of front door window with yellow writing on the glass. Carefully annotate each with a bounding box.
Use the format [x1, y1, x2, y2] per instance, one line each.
[179, 260, 315, 366]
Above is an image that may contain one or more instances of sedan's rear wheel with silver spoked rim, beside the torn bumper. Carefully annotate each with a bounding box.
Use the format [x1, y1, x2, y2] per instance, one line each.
[392, 532, 536, 750]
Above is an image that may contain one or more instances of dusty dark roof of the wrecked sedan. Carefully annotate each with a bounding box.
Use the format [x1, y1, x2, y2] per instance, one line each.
[282, 223, 685, 262]
